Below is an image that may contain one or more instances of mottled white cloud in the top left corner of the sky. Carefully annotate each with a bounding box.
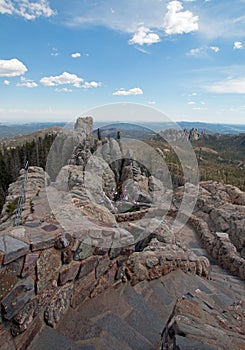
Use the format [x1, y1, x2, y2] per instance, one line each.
[0, 0, 55, 20]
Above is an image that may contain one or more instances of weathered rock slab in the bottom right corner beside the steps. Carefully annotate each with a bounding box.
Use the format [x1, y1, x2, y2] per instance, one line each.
[161, 290, 245, 350]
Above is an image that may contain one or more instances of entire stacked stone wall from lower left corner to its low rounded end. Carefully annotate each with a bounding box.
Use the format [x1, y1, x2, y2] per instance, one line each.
[0, 219, 212, 350]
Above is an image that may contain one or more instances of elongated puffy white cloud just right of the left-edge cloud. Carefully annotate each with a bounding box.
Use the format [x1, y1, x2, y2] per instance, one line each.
[40, 72, 84, 88]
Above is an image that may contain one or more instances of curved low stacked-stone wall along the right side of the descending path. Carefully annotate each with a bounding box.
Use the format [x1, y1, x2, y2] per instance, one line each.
[189, 215, 245, 280]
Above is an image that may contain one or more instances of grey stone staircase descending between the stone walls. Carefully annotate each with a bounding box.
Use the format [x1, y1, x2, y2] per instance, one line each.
[29, 226, 244, 350]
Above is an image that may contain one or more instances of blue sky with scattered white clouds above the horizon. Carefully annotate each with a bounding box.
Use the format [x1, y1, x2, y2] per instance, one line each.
[0, 0, 245, 124]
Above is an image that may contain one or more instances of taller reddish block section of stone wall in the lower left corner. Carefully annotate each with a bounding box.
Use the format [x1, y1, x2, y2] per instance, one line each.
[0, 227, 134, 350]
